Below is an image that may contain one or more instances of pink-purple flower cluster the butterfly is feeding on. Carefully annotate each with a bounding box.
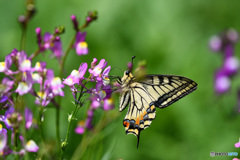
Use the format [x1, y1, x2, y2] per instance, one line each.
[63, 58, 114, 134]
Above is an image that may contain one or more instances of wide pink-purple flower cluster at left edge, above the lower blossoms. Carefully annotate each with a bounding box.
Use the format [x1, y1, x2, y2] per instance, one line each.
[0, 49, 64, 106]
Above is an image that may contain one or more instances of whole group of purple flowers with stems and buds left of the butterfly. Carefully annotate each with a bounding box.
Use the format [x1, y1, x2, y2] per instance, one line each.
[0, 1, 109, 159]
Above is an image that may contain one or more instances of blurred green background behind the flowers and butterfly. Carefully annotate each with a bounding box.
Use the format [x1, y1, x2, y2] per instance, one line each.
[0, 0, 240, 160]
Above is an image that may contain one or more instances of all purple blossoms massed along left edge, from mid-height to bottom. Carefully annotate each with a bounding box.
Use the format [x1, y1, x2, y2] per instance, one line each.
[0, 49, 64, 156]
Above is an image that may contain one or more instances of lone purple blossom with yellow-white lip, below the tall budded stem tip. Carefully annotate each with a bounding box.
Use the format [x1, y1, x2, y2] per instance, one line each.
[73, 31, 88, 55]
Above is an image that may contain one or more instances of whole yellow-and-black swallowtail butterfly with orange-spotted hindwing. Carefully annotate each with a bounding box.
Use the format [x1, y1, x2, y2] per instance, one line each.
[118, 71, 197, 146]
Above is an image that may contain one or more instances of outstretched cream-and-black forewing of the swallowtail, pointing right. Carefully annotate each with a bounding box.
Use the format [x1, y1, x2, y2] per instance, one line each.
[139, 75, 197, 108]
